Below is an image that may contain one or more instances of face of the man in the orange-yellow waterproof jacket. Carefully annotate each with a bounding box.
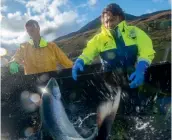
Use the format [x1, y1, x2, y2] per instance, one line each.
[26, 25, 40, 39]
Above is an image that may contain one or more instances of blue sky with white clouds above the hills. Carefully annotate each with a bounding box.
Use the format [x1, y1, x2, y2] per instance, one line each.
[0, 0, 172, 52]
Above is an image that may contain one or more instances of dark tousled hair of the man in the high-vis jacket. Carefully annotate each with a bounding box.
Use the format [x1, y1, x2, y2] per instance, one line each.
[102, 3, 125, 20]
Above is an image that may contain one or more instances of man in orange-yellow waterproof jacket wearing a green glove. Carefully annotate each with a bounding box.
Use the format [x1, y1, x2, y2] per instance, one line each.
[10, 20, 73, 75]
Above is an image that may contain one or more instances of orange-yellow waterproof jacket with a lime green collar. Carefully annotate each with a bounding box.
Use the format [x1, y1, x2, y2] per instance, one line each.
[12, 38, 73, 75]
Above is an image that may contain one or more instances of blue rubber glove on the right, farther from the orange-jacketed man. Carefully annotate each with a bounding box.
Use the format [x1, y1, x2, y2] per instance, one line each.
[129, 61, 149, 88]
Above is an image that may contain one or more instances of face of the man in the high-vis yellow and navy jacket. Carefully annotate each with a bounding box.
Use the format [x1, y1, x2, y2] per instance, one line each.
[102, 12, 120, 29]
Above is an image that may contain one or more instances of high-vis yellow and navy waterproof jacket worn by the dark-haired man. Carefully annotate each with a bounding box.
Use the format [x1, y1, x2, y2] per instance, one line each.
[79, 21, 155, 68]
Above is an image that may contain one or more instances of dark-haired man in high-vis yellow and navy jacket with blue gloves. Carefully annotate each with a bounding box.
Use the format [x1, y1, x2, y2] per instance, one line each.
[72, 4, 155, 88]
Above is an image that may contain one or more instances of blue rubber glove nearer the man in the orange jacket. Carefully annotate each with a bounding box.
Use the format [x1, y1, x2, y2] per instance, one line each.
[72, 58, 84, 80]
